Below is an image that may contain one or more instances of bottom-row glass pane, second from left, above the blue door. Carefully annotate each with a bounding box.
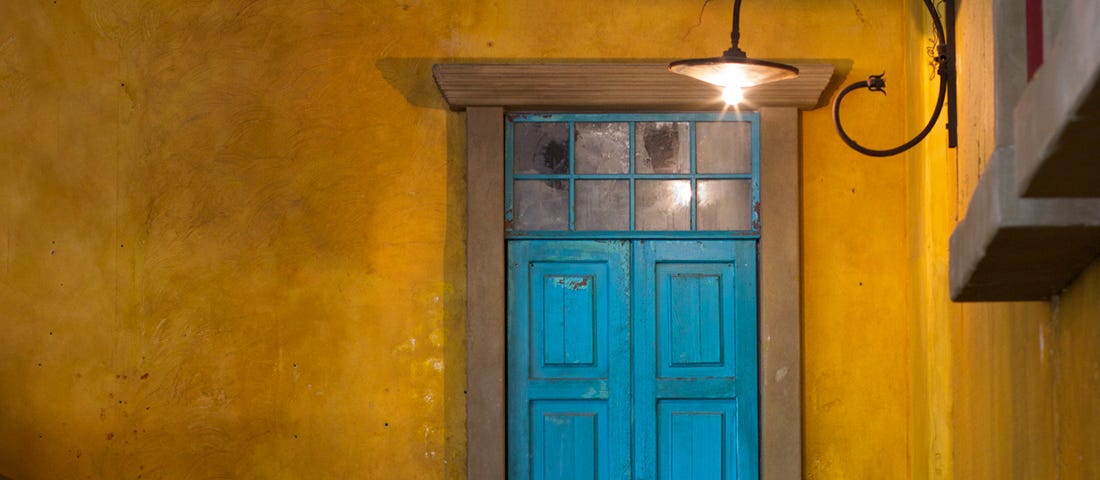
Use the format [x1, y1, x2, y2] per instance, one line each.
[573, 181, 630, 230]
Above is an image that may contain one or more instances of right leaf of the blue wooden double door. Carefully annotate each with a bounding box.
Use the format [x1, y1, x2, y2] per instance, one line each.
[633, 240, 758, 480]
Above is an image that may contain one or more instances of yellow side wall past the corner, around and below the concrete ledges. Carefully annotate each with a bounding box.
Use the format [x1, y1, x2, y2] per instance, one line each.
[909, 1, 1100, 479]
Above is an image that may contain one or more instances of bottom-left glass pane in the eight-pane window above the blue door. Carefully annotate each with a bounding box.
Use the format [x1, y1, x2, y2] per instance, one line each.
[513, 181, 569, 230]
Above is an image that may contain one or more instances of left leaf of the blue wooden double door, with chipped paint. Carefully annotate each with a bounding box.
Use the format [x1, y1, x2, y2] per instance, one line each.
[508, 240, 630, 480]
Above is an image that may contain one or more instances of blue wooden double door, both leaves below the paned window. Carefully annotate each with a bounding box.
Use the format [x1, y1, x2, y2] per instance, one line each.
[508, 240, 758, 480]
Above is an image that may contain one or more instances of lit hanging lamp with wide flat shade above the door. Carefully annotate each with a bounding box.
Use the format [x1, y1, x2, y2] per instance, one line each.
[669, 0, 799, 105]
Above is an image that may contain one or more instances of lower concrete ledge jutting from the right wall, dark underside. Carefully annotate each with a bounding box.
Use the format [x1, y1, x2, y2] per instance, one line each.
[950, 146, 1100, 302]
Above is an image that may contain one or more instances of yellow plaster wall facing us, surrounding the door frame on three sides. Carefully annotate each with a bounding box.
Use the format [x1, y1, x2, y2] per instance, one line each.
[0, 0, 912, 479]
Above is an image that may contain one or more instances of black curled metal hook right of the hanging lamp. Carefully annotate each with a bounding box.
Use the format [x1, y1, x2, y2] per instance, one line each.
[833, 0, 953, 156]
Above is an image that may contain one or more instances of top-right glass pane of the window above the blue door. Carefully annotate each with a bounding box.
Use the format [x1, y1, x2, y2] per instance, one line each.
[695, 122, 752, 173]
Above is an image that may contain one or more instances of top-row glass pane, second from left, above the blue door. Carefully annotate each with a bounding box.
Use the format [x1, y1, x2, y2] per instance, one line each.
[573, 123, 630, 173]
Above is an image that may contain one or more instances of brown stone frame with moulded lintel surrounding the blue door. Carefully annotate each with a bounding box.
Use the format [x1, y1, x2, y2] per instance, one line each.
[435, 64, 833, 480]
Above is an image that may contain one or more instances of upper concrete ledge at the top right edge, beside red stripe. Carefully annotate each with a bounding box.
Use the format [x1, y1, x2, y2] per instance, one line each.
[1013, 0, 1100, 197]
